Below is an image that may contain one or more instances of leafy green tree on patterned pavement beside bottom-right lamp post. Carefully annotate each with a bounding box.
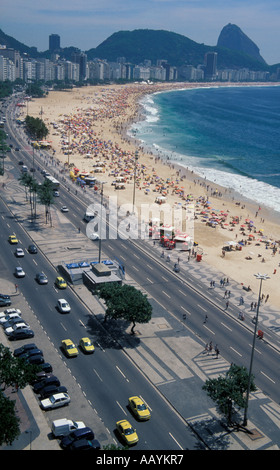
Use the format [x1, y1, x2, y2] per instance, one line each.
[202, 364, 256, 425]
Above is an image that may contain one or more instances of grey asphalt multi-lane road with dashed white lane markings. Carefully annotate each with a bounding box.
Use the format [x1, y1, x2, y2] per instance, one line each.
[1, 94, 280, 450]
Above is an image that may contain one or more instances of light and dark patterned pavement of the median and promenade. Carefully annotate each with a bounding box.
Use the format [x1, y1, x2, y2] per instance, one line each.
[0, 152, 280, 450]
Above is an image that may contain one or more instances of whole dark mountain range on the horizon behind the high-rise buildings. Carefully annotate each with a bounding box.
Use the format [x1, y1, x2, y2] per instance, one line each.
[0, 25, 270, 70]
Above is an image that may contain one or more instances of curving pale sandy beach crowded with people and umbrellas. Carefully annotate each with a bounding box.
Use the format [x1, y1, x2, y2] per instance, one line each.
[25, 83, 280, 307]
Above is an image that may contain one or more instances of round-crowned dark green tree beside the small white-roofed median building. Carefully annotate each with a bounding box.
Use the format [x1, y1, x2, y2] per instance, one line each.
[97, 283, 152, 334]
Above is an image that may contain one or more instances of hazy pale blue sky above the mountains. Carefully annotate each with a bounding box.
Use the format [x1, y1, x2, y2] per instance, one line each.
[0, 0, 280, 65]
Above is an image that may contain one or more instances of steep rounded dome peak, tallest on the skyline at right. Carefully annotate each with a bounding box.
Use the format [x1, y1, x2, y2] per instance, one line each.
[217, 23, 266, 64]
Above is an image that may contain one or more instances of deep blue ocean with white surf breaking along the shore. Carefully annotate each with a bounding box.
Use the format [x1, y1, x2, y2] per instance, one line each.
[129, 86, 280, 213]
